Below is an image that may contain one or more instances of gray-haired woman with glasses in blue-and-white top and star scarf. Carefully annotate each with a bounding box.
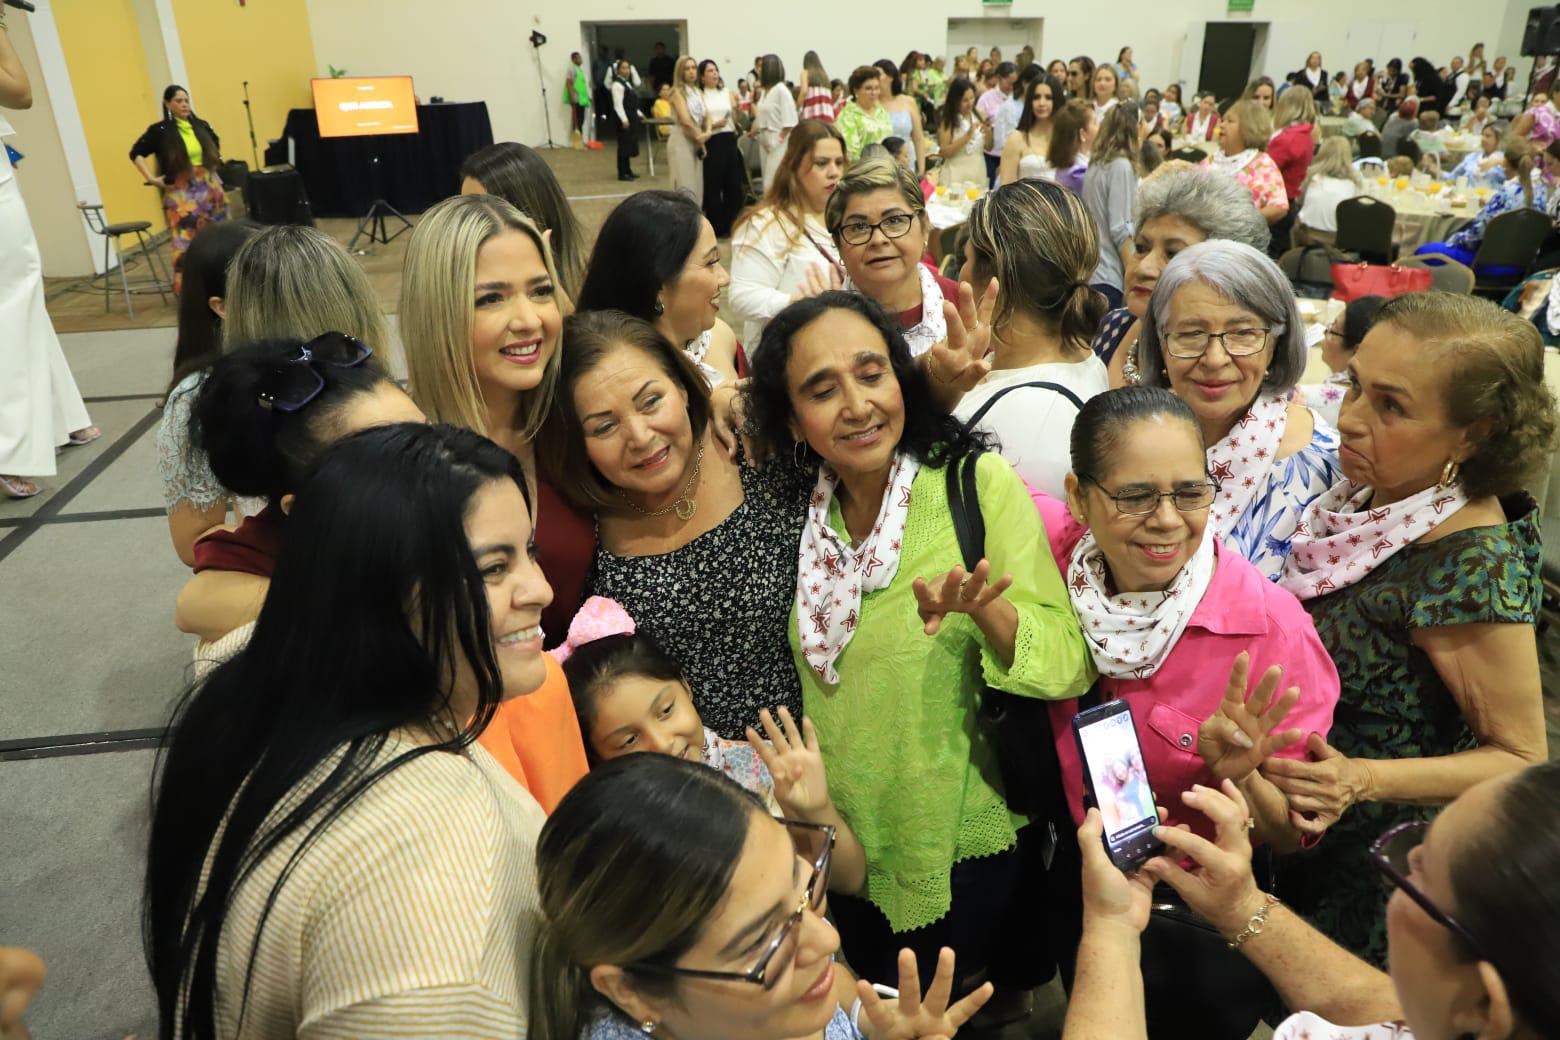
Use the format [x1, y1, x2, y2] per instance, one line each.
[1137, 242, 1342, 580]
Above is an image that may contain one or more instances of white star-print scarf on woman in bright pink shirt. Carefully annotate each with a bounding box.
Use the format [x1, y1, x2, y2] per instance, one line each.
[1067, 529, 1214, 678]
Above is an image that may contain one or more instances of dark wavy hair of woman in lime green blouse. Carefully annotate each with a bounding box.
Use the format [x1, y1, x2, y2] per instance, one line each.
[743, 290, 989, 466]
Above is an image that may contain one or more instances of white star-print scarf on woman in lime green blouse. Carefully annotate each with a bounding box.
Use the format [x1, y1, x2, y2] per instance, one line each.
[796, 452, 920, 686]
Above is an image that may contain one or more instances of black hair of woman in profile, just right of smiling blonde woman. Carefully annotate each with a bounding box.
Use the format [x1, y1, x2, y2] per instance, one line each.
[576, 192, 704, 321]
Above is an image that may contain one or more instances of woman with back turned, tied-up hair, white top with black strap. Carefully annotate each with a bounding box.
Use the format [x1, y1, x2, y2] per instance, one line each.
[953, 179, 1109, 496]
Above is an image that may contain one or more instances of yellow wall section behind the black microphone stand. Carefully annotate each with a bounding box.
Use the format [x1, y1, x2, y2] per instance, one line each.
[173, 0, 315, 165]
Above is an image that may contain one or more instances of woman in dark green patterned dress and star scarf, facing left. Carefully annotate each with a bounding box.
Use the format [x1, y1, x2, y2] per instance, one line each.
[1262, 293, 1555, 964]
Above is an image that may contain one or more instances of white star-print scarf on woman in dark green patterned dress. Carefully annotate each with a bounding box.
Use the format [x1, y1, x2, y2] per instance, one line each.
[1278, 479, 1468, 599]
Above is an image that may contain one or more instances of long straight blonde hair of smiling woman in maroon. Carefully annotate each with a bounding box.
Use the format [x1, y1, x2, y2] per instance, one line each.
[401, 195, 563, 441]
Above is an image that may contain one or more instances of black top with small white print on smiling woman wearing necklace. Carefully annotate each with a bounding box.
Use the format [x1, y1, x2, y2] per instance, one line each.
[585, 460, 817, 741]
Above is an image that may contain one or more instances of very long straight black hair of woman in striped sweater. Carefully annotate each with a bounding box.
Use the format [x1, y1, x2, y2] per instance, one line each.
[142, 424, 529, 1040]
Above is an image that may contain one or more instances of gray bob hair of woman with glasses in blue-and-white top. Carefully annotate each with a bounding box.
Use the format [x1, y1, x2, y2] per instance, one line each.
[1137, 240, 1309, 393]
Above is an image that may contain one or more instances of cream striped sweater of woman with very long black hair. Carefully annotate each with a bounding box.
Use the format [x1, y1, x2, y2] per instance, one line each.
[205, 742, 544, 1040]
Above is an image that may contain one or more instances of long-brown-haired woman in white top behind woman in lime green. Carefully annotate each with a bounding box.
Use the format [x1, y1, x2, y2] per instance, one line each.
[729, 117, 846, 346]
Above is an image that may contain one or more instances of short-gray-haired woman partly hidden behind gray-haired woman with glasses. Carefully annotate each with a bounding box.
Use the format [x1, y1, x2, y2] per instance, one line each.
[1092, 164, 1270, 387]
